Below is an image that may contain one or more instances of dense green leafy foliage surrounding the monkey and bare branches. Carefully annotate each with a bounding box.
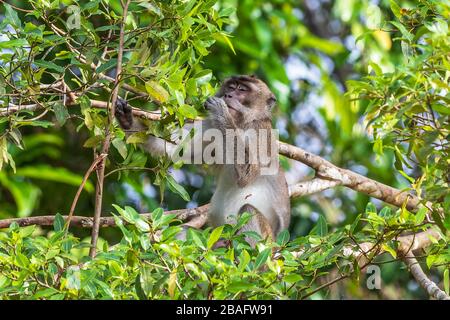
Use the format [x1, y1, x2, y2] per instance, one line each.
[0, 0, 450, 299]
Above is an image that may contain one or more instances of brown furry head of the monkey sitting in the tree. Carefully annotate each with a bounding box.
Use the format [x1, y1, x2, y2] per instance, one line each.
[216, 75, 277, 114]
